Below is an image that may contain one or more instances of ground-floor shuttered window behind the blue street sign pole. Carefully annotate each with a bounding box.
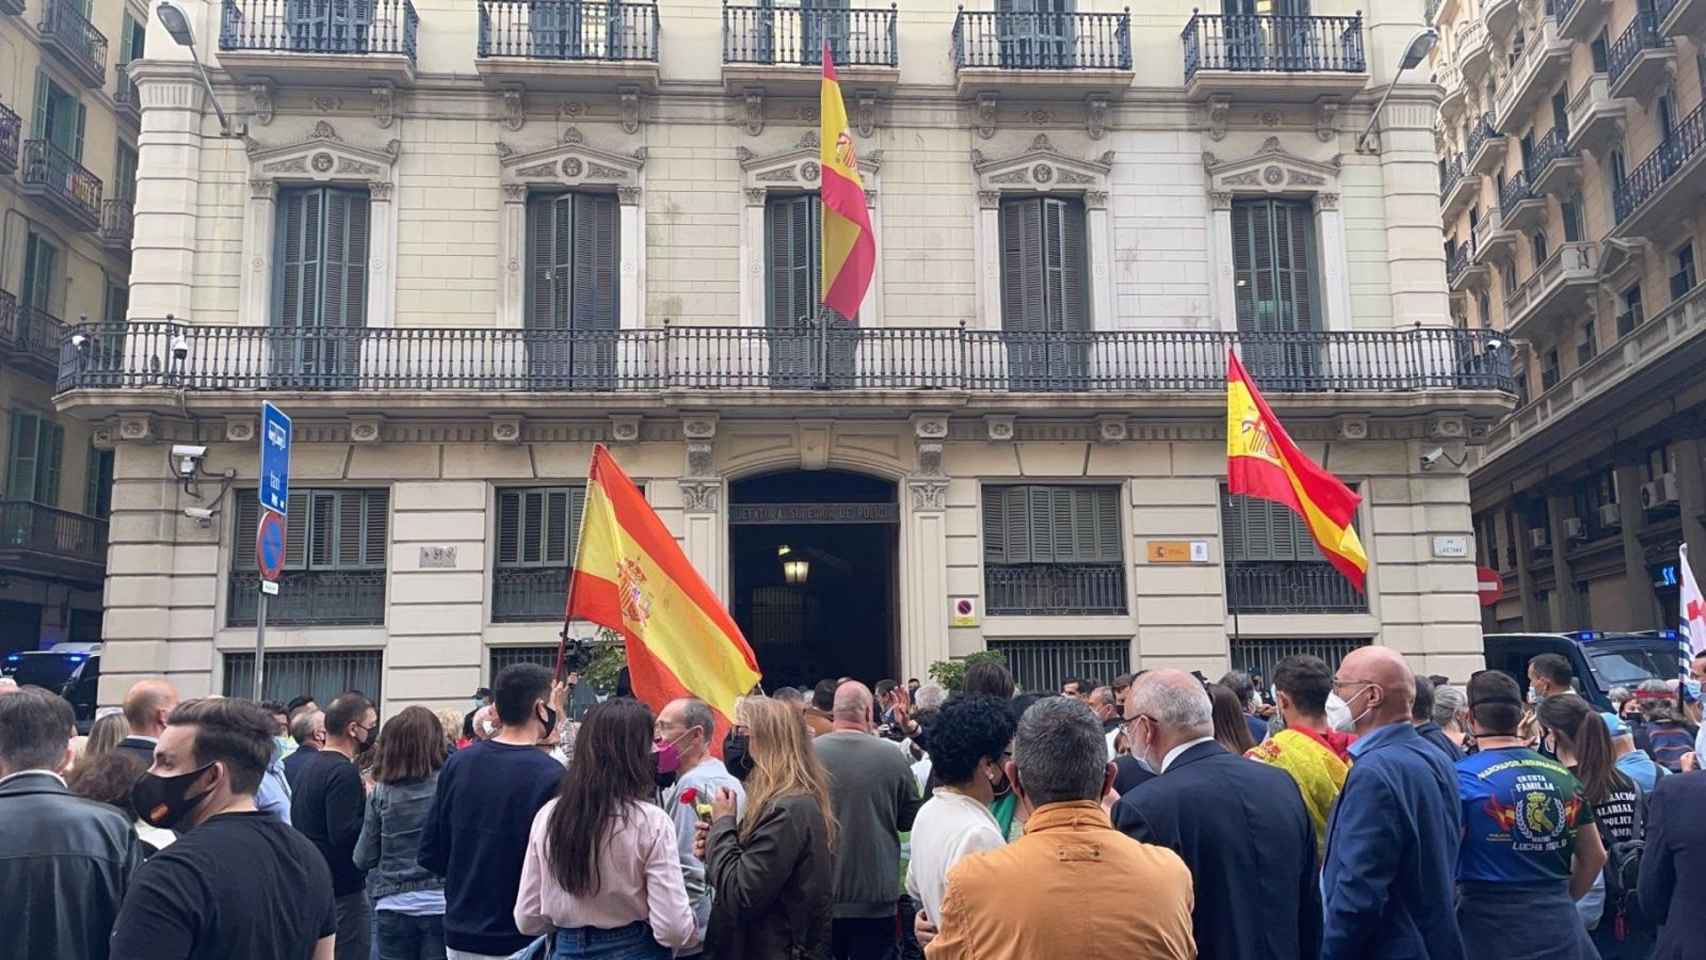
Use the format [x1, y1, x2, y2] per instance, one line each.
[232, 489, 391, 575]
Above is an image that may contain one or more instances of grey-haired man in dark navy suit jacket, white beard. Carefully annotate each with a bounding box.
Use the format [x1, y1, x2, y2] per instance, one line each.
[1114, 670, 1320, 960]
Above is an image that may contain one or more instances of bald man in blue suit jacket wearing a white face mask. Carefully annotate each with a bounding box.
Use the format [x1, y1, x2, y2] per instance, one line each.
[1320, 646, 1465, 960]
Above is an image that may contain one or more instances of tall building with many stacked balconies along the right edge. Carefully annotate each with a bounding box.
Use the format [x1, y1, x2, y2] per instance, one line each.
[1433, 0, 1706, 629]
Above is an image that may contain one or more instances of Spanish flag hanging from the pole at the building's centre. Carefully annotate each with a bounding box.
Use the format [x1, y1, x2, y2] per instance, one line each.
[817, 39, 877, 319]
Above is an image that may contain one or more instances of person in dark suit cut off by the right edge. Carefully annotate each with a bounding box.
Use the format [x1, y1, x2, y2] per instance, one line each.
[1639, 771, 1706, 960]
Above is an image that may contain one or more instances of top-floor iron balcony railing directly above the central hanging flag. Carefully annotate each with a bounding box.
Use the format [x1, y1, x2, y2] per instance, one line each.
[723, 3, 901, 67]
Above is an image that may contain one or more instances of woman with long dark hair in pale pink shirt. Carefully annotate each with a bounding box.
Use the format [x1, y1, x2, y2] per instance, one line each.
[515, 697, 698, 960]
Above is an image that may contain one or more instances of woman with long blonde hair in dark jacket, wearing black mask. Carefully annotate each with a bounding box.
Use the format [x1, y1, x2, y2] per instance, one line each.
[698, 697, 836, 960]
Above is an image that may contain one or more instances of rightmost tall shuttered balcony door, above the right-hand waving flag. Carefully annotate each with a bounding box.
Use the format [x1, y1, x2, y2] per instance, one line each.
[1232, 200, 1320, 389]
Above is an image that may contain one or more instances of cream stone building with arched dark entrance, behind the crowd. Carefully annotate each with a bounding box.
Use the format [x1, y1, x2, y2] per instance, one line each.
[58, 0, 1512, 709]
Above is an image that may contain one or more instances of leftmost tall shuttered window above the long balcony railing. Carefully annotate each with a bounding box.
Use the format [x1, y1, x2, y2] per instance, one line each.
[273, 188, 370, 327]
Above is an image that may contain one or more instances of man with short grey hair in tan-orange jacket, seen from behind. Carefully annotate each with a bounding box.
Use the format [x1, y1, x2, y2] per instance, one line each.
[928, 697, 1194, 960]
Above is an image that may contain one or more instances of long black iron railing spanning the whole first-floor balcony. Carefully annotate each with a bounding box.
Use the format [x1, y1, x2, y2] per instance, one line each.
[60, 321, 1512, 392]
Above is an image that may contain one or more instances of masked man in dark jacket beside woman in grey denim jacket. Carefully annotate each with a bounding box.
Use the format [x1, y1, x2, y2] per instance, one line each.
[290, 694, 379, 960]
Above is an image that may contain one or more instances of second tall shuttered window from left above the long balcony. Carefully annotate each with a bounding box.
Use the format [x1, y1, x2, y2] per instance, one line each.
[527, 193, 621, 331]
